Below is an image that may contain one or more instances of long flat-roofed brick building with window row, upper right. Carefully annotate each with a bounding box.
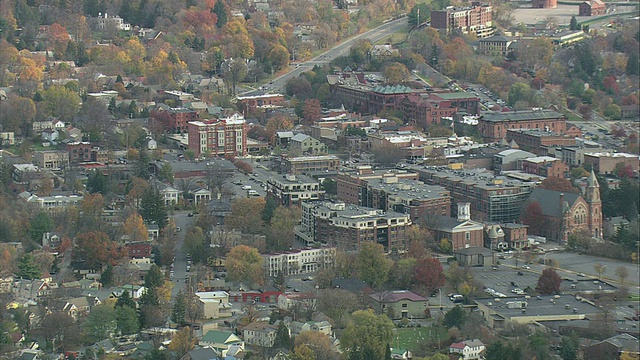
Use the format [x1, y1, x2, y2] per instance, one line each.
[478, 110, 567, 142]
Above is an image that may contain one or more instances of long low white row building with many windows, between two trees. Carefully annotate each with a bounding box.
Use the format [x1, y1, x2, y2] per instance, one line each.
[262, 247, 336, 276]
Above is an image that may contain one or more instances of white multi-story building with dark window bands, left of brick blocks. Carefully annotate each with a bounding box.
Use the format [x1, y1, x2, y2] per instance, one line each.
[267, 174, 325, 206]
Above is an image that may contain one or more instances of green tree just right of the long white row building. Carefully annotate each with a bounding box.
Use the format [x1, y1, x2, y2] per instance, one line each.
[356, 242, 392, 288]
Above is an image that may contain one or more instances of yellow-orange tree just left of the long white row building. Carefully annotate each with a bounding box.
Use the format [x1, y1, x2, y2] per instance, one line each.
[226, 245, 264, 285]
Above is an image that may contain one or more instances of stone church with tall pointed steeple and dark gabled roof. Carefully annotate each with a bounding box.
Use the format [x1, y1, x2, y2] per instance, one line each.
[527, 170, 603, 244]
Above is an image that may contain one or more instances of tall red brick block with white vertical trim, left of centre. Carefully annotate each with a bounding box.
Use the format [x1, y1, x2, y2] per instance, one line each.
[187, 114, 247, 157]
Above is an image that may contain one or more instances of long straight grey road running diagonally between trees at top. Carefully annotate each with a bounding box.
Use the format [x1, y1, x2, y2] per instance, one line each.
[268, 17, 409, 92]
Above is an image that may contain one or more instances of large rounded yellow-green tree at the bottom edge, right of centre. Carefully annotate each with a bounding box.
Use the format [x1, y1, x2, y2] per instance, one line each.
[340, 309, 394, 359]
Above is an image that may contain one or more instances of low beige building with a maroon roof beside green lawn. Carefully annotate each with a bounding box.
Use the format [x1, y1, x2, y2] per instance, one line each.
[369, 290, 429, 320]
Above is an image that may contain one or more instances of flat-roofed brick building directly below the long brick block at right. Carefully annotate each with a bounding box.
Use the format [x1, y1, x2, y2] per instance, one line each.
[507, 129, 576, 156]
